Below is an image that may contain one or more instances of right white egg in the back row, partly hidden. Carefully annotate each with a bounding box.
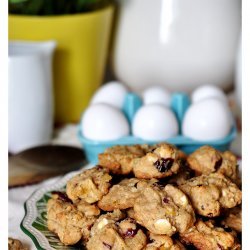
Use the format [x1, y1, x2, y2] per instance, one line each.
[191, 85, 227, 103]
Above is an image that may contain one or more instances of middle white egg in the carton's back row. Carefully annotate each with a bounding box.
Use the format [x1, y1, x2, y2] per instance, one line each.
[142, 86, 171, 107]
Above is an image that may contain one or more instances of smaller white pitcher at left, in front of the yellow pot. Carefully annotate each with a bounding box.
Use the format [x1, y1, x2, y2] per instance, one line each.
[8, 41, 56, 153]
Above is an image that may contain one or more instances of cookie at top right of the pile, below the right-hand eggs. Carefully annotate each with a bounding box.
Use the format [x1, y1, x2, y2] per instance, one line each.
[187, 146, 240, 184]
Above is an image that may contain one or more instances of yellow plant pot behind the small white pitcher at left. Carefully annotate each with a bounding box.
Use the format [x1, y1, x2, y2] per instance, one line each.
[9, 5, 114, 123]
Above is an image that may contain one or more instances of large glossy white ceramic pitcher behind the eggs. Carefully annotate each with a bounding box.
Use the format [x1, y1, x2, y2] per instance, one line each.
[113, 0, 241, 92]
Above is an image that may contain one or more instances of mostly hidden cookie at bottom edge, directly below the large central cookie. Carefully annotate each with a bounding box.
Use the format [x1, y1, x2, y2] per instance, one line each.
[145, 233, 185, 250]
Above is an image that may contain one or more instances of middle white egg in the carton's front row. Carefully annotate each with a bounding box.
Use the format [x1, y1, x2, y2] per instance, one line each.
[132, 104, 178, 141]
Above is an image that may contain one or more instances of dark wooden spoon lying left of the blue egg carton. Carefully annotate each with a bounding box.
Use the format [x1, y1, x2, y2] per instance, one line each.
[9, 145, 87, 187]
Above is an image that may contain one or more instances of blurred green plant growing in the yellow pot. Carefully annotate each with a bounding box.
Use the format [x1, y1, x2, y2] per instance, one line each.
[9, 0, 112, 16]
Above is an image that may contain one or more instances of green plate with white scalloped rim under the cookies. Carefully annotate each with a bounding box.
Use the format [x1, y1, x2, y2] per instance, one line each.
[20, 164, 93, 250]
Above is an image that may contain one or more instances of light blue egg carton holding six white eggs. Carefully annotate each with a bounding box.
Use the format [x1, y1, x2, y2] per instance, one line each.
[78, 92, 237, 164]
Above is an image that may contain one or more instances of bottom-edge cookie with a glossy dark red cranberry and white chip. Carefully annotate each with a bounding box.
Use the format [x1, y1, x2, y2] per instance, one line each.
[87, 210, 147, 250]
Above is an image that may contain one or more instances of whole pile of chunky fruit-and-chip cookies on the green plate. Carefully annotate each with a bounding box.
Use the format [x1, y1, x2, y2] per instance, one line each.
[47, 143, 242, 250]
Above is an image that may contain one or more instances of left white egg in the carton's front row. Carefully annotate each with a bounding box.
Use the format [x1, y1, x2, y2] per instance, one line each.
[81, 104, 129, 141]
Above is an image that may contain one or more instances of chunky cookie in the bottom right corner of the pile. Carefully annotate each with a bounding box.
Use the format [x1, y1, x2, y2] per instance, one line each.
[180, 220, 240, 250]
